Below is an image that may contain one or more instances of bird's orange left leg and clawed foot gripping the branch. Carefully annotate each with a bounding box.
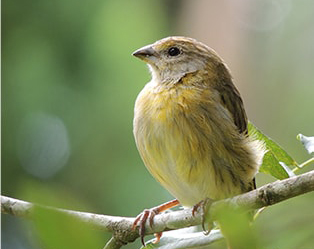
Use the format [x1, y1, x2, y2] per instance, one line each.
[132, 199, 180, 246]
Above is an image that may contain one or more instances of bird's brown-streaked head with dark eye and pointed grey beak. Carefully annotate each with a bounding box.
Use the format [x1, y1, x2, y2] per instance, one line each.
[133, 36, 223, 84]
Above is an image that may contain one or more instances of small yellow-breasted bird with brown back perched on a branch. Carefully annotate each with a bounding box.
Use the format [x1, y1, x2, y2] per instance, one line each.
[133, 36, 264, 245]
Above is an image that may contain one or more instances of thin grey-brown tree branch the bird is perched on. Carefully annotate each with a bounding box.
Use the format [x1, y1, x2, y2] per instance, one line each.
[1, 170, 314, 249]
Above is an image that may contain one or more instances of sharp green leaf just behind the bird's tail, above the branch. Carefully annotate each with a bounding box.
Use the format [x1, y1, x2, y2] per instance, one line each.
[248, 122, 298, 179]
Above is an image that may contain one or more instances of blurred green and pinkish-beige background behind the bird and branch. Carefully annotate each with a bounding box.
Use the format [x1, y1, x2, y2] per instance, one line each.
[2, 0, 314, 249]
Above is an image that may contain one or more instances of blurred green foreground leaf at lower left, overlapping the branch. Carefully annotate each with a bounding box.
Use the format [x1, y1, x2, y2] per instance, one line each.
[19, 180, 103, 249]
